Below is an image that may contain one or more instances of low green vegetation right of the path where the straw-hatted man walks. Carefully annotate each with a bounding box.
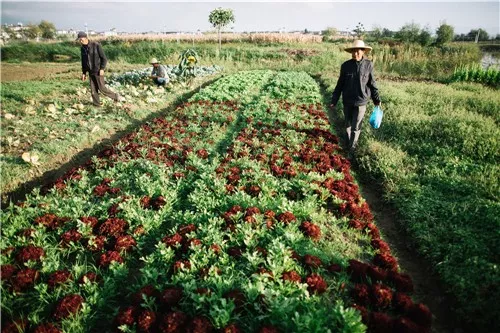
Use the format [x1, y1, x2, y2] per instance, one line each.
[320, 77, 500, 332]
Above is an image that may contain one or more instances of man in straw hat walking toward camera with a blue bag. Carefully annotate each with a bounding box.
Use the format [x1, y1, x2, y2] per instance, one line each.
[328, 40, 380, 159]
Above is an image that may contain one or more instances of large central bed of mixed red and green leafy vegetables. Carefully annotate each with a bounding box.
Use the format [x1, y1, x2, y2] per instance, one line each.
[1, 70, 431, 332]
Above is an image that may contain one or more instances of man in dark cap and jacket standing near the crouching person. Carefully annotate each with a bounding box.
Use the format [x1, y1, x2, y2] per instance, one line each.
[76, 31, 124, 106]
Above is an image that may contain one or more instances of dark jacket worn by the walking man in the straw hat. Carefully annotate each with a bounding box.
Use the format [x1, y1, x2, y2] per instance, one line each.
[332, 58, 380, 106]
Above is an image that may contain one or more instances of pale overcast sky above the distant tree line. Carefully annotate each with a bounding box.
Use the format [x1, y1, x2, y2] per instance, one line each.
[0, 0, 500, 36]
